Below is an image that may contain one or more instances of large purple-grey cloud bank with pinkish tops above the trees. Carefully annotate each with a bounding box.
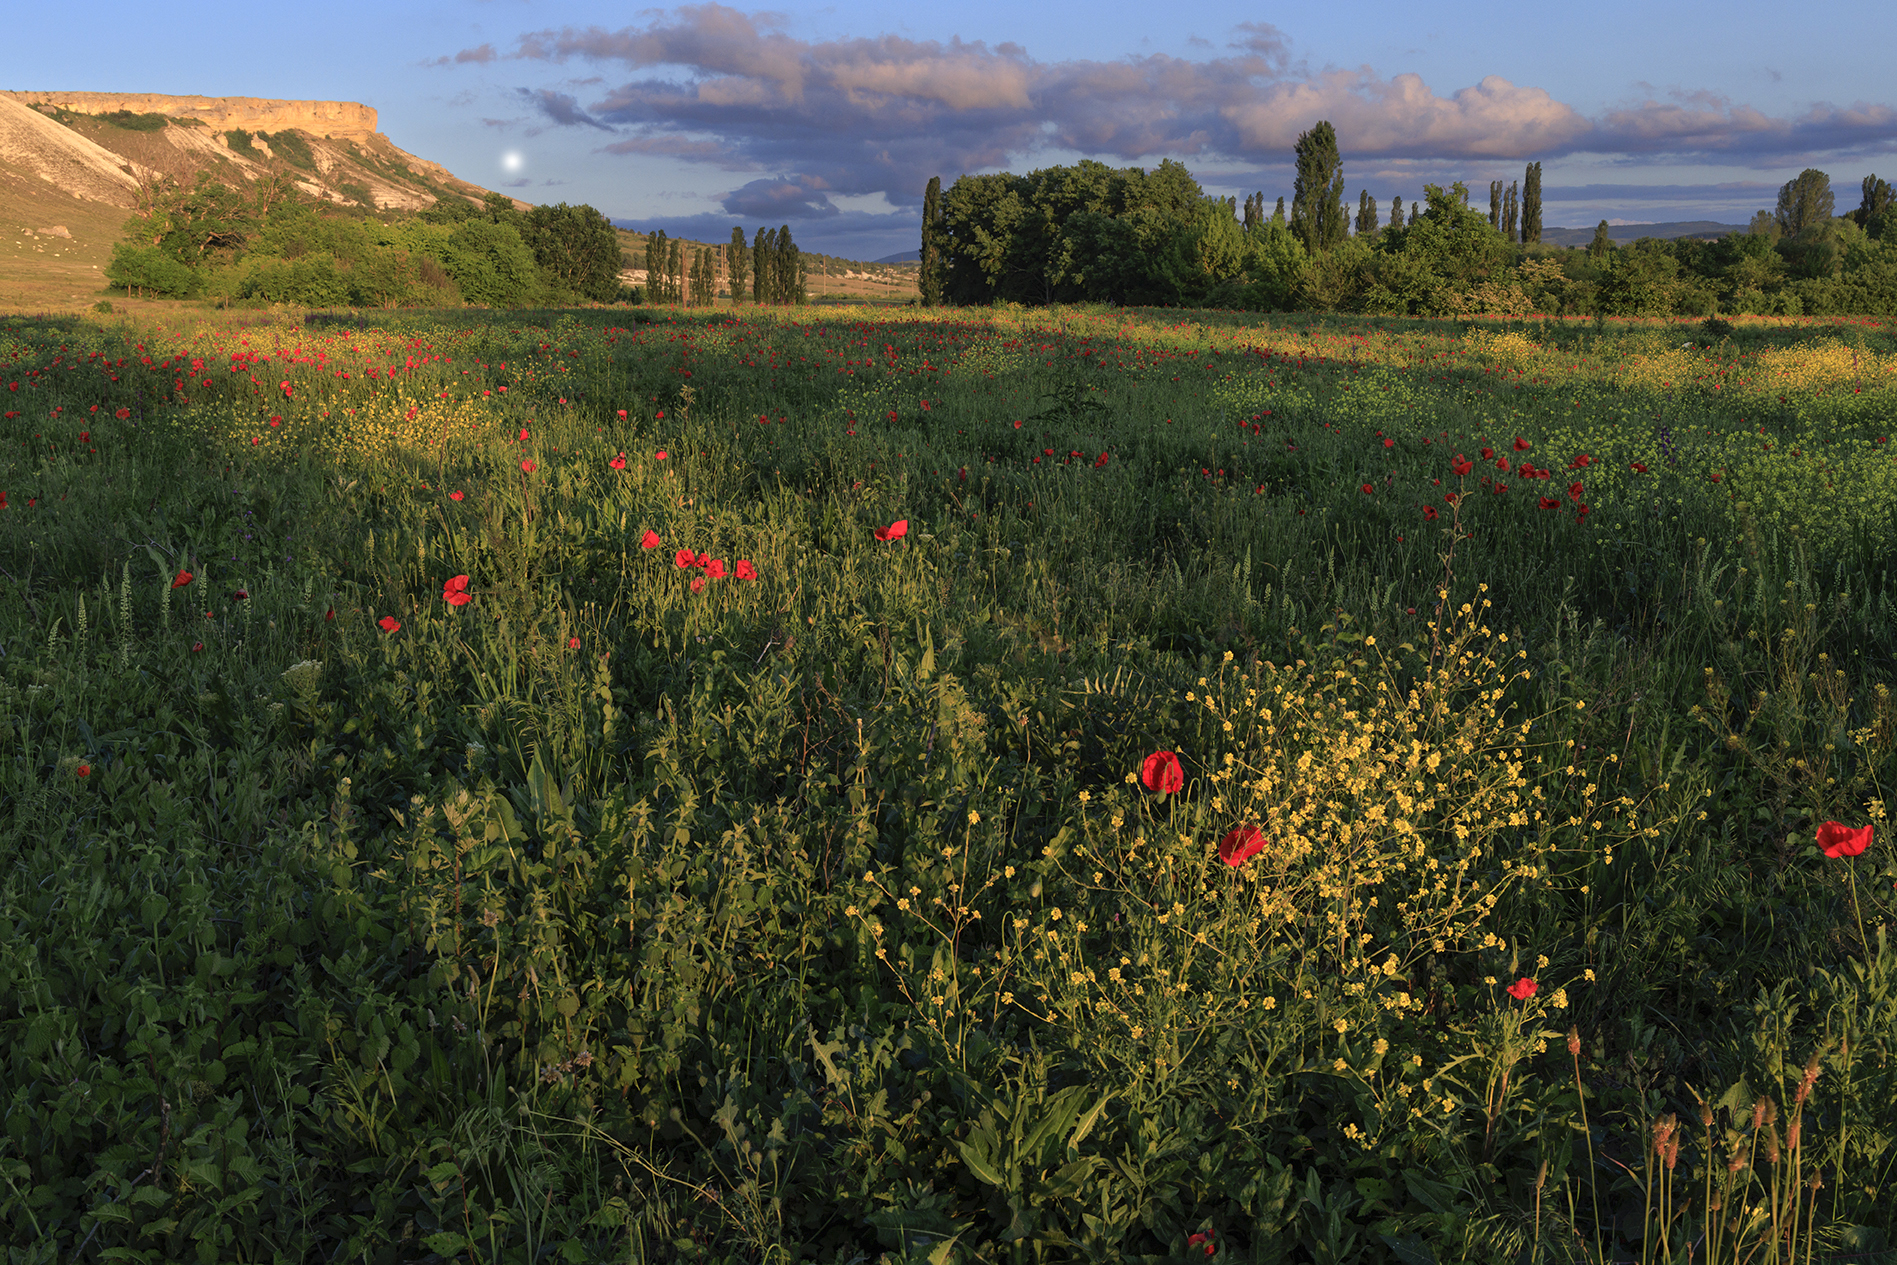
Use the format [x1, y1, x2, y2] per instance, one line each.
[455, 2, 1897, 218]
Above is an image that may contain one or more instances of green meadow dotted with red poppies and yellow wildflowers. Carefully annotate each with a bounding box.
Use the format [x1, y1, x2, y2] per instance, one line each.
[0, 307, 1897, 1265]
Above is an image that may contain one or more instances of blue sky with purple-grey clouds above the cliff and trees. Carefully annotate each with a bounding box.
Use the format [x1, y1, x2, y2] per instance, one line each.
[0, 0, 1897, 258]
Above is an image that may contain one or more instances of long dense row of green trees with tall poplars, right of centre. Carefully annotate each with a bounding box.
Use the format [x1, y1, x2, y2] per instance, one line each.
[918, 121, 1897, 317]
